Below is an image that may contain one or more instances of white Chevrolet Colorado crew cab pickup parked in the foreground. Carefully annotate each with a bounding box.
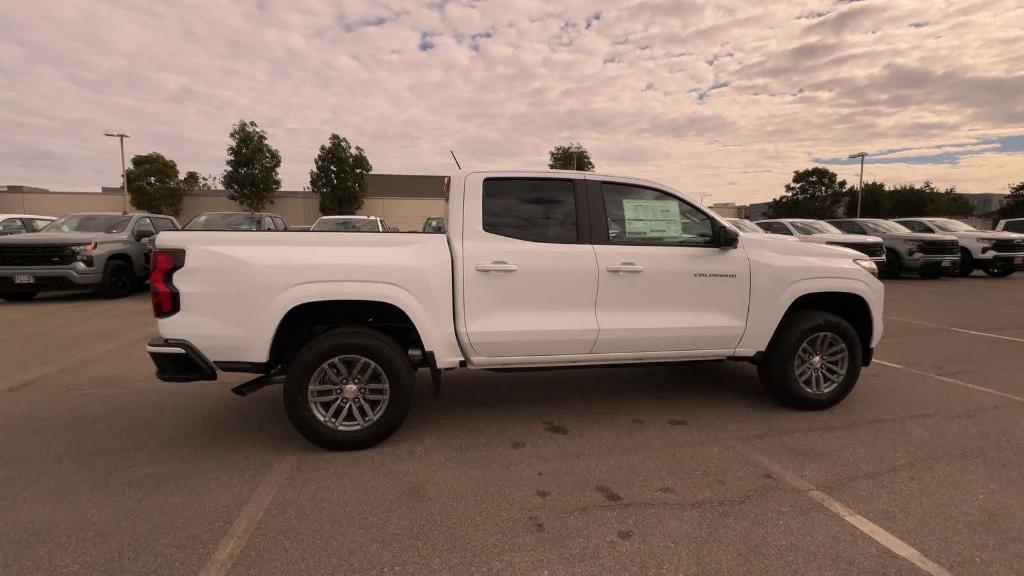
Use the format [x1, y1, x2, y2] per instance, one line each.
[146, 171, 883, 450]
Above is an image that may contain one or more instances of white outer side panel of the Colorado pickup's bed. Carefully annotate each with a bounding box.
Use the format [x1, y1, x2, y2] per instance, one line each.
[157, 231, 462, 366]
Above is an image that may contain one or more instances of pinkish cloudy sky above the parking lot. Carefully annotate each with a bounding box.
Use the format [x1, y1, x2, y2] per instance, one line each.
[0, 0, 1024, 203]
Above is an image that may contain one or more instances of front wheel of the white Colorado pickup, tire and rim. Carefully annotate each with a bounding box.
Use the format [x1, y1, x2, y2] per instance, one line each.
[758, 311, 863, 410]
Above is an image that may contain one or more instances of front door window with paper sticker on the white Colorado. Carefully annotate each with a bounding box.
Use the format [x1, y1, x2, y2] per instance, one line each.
[601, 182, 712, 245]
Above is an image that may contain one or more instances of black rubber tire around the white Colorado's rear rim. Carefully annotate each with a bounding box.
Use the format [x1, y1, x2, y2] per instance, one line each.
[284, 328, 416, 450]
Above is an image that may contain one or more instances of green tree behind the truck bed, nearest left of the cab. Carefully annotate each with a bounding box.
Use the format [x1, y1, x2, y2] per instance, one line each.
[309, 134, 374, 215]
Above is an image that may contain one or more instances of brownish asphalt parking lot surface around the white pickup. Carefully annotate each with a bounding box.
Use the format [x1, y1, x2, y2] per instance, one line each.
[0, 273, 1024, 575]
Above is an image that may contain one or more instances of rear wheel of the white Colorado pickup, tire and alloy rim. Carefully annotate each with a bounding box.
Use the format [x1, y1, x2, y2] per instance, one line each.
[285, 328, 416, 450]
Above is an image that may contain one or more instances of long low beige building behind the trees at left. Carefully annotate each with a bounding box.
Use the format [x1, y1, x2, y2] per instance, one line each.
[0, 174, 445, 232]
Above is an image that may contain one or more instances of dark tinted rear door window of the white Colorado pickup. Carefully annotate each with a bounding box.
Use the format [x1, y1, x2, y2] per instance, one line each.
[483, 178, 578, 242]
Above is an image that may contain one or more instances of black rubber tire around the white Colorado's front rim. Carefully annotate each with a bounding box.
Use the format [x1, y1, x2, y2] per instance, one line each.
[758, 310, 863, 410]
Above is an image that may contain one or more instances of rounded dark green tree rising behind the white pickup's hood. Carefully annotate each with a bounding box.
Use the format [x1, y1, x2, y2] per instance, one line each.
[768, 166, 856, 219]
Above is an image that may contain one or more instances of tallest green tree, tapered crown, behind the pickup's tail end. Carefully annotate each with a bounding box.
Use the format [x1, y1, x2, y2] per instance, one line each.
[221, 120, 281, 212]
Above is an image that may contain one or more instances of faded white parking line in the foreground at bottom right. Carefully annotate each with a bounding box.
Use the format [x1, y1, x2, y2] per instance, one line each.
[736, 446, 952, 576]
